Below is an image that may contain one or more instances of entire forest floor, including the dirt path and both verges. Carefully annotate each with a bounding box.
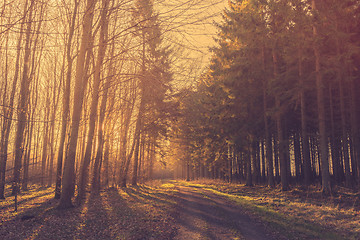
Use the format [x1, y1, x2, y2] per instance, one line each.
[0, 180, 360, 240]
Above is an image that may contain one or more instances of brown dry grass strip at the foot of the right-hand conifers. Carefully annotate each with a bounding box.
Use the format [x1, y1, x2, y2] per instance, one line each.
[186, 179, 360, 239]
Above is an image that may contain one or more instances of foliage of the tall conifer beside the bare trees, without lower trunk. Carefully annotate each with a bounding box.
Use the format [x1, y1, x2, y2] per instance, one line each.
[133, 0, 176, 144]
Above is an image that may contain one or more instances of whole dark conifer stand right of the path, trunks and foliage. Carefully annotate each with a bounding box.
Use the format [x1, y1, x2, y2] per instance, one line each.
[175, 1, 360, 194]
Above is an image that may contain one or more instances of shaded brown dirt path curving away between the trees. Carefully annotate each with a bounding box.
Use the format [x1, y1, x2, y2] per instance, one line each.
[175, 186, 279, 240]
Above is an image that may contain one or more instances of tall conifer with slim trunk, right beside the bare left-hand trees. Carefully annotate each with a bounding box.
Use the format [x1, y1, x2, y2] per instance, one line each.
[132, 0, 171, 185]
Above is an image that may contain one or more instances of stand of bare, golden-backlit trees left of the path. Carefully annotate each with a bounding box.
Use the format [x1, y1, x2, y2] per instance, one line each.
[0, 0, 216, 208]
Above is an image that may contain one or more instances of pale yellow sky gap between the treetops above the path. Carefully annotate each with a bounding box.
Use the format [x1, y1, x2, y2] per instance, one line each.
[155, 0, 228, 85]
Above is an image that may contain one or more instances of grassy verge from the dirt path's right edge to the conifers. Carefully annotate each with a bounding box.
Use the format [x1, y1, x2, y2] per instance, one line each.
[178, 180, 360, 240]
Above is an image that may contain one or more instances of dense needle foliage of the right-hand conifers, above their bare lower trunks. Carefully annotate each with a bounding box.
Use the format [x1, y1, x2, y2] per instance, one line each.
[170, 0, 360, 185]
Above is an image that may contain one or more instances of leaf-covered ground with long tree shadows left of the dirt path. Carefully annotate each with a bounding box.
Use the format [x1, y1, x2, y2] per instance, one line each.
[0, 184, 176, 240]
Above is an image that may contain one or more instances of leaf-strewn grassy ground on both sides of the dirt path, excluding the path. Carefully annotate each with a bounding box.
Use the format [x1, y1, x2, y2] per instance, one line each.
[0, 180, 360, 240]
